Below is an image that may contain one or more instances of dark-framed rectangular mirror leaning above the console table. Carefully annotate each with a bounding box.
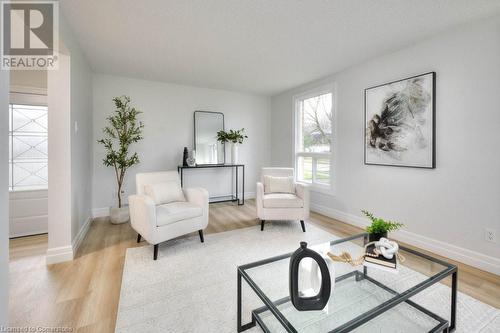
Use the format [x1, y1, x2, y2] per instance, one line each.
[194, 111, 226, 165]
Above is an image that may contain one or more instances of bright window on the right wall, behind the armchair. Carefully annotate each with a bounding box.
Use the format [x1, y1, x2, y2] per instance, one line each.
[295, 89, 333, 191]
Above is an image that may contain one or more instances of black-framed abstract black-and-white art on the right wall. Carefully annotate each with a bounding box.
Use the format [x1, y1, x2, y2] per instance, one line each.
[364, 72, 436, 169]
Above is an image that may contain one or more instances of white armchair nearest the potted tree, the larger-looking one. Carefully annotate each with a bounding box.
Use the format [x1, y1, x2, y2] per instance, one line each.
[129, 171, 208, 260]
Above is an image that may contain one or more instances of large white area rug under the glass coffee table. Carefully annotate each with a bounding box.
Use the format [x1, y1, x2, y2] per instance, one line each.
[116, 222, 500, 333]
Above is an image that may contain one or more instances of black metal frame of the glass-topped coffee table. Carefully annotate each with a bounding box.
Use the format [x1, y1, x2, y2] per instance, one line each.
[237, 233, 458, 333]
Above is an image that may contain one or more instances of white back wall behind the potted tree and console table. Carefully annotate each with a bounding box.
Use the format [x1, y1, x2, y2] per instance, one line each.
[93, 74, 270, 208]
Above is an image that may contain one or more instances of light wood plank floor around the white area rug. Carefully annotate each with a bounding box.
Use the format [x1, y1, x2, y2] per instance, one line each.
[9, 200, 500, 332]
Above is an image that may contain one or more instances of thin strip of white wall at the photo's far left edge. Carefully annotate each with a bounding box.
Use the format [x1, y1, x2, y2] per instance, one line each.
[0, 63, 9, 327]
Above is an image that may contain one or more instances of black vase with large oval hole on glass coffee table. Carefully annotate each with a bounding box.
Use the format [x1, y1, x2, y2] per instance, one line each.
[290, 242, 331, 311]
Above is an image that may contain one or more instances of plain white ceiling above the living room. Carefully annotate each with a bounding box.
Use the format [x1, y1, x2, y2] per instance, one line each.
[61, 0, 500, 95]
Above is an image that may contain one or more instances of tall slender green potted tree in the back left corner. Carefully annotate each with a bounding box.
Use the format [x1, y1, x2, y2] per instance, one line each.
[97, 96, 144, 224]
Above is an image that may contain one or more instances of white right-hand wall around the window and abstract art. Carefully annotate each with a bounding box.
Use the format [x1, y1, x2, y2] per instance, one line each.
[271, 18, 500, 274]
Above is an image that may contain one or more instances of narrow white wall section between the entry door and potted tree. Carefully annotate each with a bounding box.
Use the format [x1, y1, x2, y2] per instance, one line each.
[47, 12, 93, 263]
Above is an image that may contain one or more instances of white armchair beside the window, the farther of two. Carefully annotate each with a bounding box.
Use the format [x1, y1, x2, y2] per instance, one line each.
[256, 168, 310, 232]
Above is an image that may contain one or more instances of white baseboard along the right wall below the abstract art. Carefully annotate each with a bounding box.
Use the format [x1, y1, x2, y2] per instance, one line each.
[311, 204, 500, 275]
